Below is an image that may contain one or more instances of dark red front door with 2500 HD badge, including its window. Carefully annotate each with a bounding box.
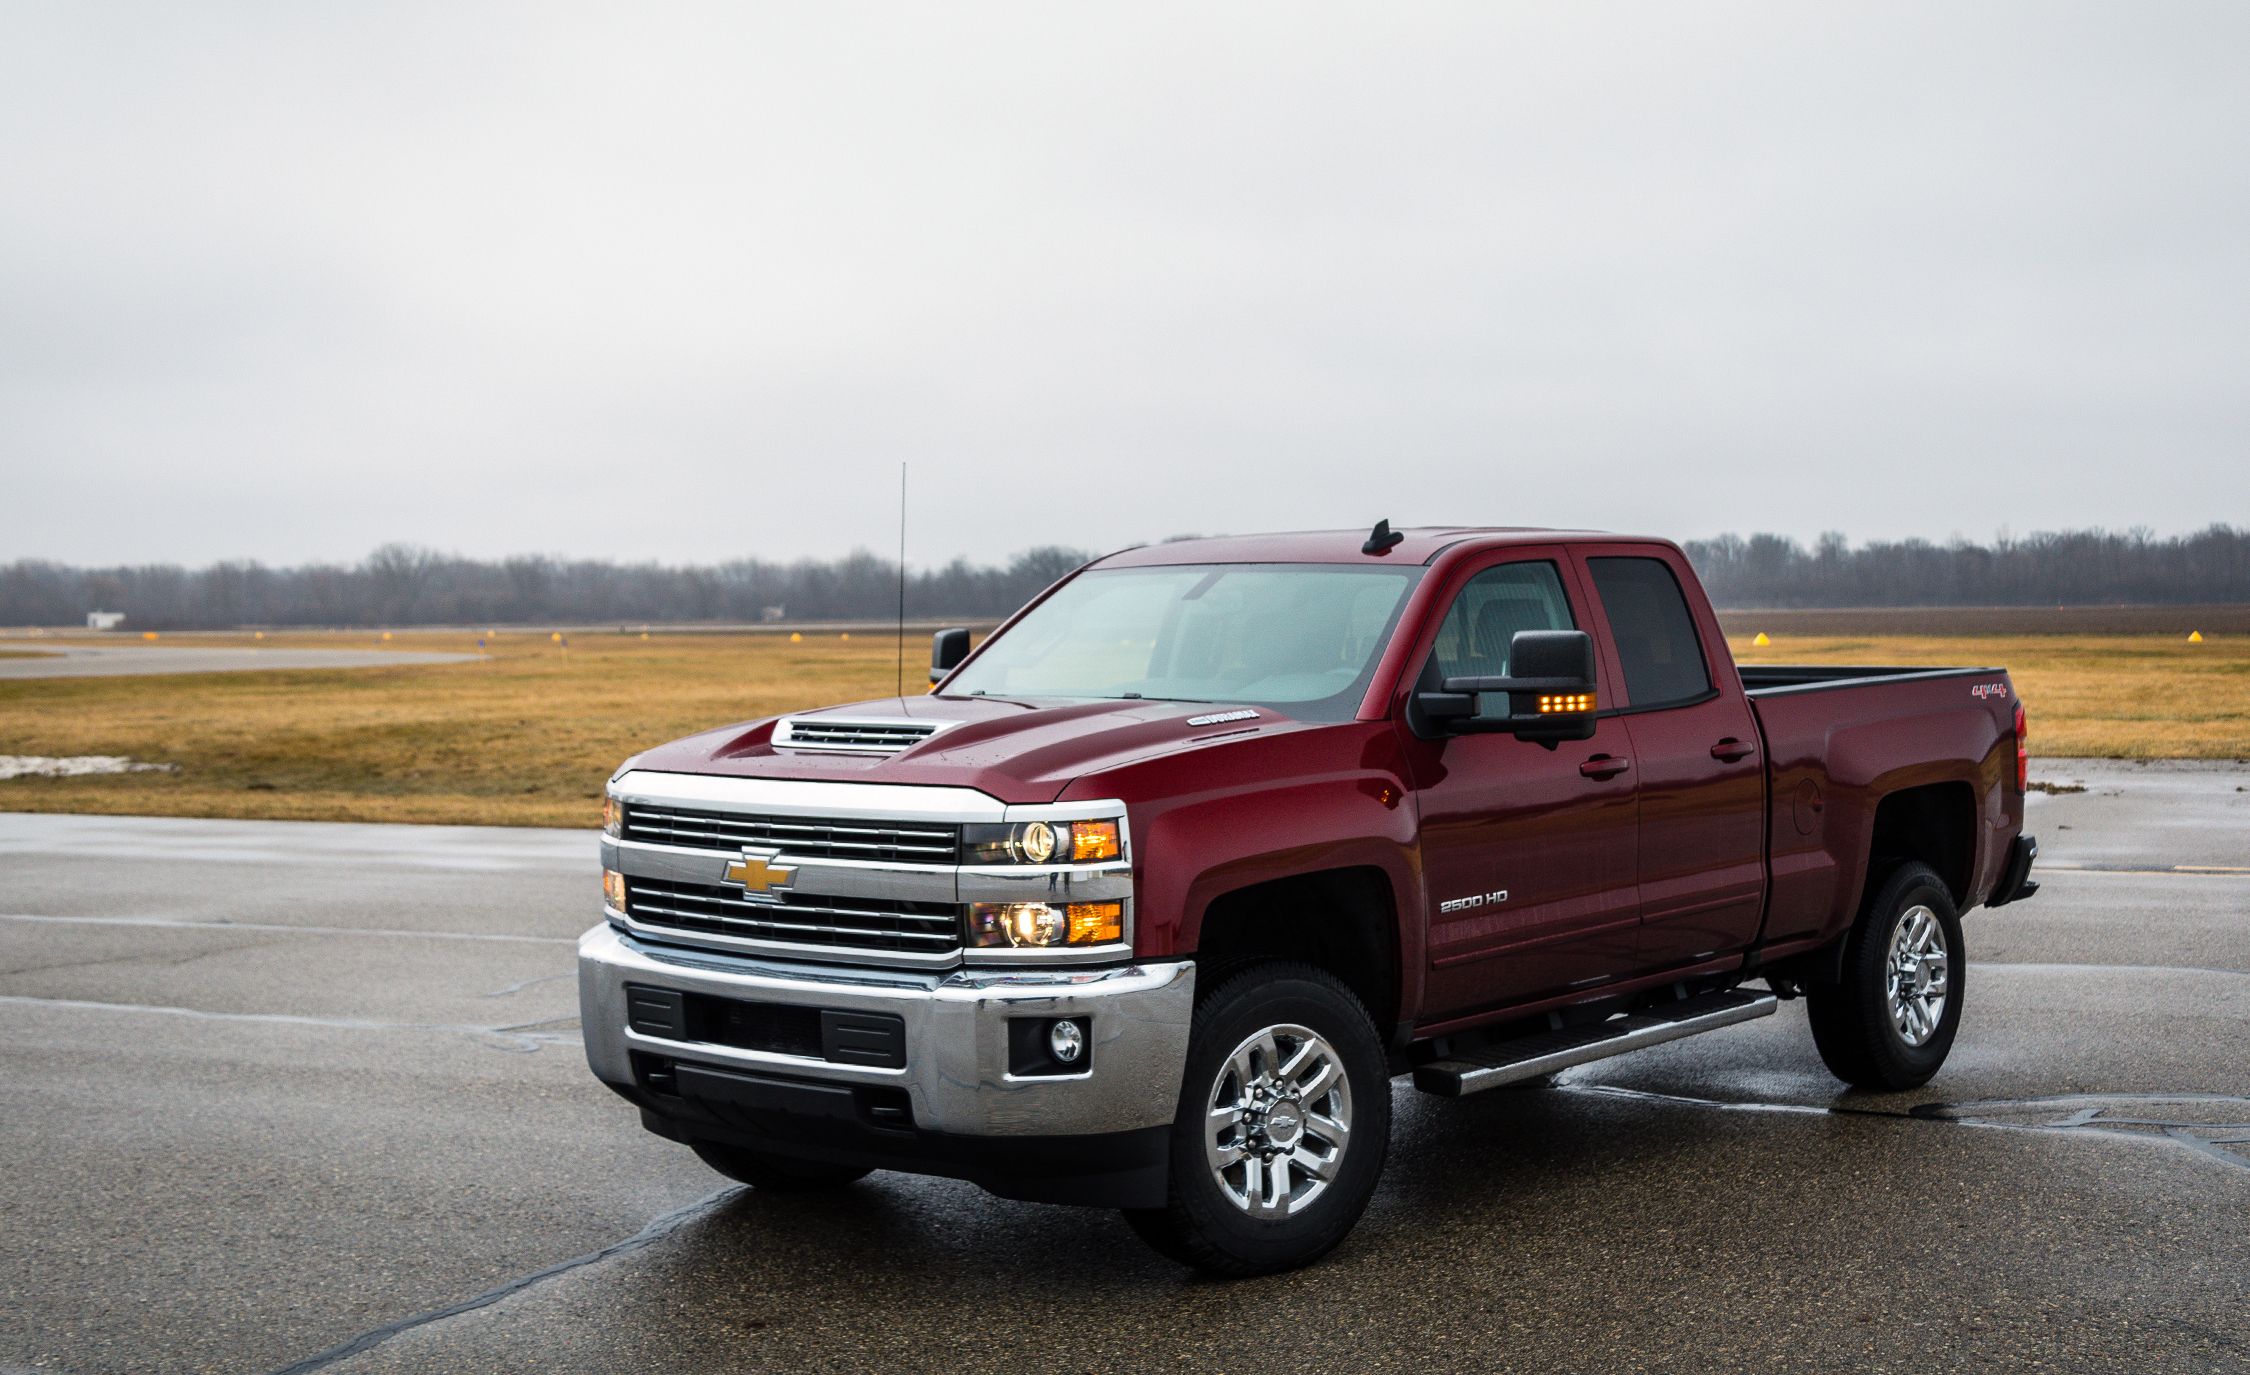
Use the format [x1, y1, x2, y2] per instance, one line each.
[1406, 549, 1638, 1022]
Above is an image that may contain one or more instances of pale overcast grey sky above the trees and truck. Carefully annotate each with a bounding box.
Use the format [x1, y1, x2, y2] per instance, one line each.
[0, 0, 2250, 563]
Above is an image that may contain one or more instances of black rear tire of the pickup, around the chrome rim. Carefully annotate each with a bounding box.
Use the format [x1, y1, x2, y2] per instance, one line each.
[1805, 864, 1969, 1091]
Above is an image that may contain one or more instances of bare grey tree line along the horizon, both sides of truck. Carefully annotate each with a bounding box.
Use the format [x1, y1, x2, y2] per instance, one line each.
[0, 524, 2250, 630]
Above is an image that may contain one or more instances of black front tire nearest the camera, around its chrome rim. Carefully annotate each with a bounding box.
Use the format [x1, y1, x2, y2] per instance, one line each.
[1125, 963, 1391, 1278]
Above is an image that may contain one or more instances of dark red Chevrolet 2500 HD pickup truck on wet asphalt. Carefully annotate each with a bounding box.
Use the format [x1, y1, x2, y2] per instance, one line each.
[578, 524, 2036, 1274]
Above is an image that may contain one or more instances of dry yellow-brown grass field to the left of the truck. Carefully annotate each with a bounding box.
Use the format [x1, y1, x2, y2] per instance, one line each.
[0, 630, 909, 826]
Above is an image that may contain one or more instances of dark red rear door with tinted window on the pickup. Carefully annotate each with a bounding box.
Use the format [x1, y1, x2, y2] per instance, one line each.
[1575, 545, 1766, 968]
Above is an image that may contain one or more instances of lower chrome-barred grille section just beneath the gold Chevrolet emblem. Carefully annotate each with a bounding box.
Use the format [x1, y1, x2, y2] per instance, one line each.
[626, 878, 961, 954]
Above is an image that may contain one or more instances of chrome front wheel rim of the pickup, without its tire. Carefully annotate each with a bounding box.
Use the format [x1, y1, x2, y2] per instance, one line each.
[1204, 1026, 1352, 1220]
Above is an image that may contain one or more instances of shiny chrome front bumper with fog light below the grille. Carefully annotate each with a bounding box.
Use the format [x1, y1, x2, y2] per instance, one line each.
[578, 923, 1195, 1136]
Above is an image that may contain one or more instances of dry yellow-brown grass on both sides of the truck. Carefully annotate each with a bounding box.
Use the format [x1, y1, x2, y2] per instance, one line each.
[0, 608, 2250, 826]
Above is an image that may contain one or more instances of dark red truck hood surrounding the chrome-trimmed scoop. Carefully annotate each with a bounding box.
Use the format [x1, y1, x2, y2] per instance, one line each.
[619, 698, 1314, 803]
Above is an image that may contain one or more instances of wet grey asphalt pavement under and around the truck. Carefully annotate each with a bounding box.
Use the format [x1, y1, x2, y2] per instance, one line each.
[0, 761, 2250, 1373]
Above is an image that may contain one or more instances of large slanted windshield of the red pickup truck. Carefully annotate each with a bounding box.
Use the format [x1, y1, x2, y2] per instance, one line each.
[945, 563, 1422, 720]
